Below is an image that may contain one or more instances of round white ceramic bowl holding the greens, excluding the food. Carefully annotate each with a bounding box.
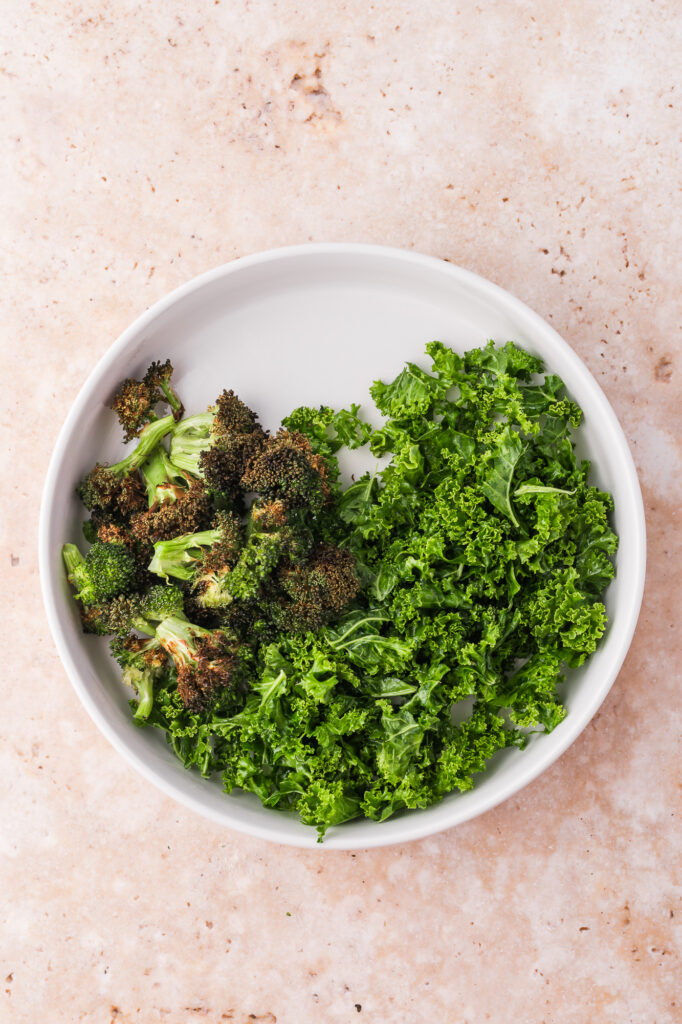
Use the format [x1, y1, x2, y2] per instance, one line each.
[40, 245, 645, 850]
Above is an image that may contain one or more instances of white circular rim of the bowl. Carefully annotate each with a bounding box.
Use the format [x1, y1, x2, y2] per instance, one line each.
[38, 242, 646, 851]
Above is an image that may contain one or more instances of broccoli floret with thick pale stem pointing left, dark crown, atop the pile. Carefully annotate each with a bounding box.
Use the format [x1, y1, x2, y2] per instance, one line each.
[170, 391, 265, 497]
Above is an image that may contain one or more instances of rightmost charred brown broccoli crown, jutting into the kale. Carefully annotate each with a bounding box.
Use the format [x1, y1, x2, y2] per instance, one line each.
[275, 544, 359, 633]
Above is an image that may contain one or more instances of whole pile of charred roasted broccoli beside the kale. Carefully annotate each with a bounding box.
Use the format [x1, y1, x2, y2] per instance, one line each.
[63, 360, 358, 782]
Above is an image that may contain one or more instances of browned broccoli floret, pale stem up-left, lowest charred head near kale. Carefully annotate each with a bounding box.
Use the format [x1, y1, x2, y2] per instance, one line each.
[156, 614, 239, 711]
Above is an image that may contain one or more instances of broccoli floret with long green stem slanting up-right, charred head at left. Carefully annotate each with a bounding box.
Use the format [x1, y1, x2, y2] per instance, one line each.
[78, 416, 175, 516]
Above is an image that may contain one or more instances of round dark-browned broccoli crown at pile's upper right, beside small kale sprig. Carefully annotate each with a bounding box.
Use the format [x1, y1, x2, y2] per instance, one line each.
[242, 430, 330, 512]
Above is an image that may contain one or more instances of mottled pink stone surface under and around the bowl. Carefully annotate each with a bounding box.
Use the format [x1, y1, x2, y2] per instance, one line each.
[0, 0, 682, 1024]
